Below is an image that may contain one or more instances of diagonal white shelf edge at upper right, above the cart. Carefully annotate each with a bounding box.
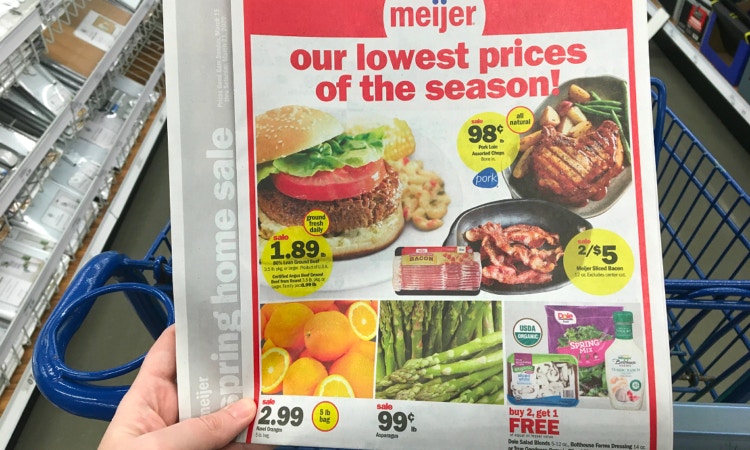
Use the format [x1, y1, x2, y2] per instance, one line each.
[647, 0, 750, 151]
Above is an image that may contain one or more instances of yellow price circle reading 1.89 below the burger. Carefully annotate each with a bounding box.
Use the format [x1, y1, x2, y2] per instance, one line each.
[260, 221, 333, 297]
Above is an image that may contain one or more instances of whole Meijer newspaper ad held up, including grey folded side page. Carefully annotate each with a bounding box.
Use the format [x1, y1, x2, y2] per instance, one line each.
[160, 0, 672, 450]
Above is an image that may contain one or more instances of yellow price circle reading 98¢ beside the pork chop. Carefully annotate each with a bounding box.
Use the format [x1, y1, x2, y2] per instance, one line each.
[456, 112, 521, 172]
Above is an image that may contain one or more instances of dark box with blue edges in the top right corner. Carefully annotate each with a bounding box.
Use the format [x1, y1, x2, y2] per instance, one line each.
[700, 0, 750, 86]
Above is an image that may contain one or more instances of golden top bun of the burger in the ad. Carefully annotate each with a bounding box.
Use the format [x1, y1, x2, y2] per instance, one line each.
[255, 105, 344, 164]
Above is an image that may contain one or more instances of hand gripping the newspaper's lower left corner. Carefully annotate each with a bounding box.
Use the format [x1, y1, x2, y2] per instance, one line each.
[99, 325, 256, 450]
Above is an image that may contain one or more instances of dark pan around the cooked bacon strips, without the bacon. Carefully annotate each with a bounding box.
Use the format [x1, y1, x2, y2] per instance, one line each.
[443, 200, 591, 294]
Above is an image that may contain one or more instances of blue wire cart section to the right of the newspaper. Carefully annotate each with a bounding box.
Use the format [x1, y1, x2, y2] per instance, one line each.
[652, 80, 750, 449]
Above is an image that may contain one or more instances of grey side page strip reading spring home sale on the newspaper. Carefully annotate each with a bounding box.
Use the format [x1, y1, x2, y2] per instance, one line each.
[164, 0, 247, 428]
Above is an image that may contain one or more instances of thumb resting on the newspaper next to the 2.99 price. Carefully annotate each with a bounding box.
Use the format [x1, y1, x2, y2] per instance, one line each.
[142, 399, 257, 450]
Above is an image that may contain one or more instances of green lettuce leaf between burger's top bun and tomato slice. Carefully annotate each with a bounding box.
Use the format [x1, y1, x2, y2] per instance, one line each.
[258, 127, 385, 182]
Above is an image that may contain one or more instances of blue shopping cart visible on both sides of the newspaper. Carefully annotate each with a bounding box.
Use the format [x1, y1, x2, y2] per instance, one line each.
[33, 79, 750, 449]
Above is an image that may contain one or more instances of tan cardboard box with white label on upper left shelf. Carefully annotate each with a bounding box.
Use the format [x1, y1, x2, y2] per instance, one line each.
[47, 0, 132, 78]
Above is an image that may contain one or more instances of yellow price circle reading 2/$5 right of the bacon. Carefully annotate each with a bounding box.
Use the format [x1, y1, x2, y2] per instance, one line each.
[563, 228, 635, 295]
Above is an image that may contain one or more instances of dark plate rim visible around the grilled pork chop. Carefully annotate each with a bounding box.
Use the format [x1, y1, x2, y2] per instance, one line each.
[503, 77, 633, 217]
